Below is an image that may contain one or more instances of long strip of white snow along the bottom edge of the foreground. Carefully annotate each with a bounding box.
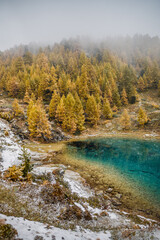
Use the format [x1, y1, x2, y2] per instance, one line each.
[0, 214, 111, 240]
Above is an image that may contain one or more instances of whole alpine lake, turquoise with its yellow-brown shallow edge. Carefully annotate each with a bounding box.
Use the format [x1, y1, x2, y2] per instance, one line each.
[67, 137, 160, 218]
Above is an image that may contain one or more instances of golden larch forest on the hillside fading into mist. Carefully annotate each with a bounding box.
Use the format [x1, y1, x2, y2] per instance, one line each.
[0, 36, 160, 138]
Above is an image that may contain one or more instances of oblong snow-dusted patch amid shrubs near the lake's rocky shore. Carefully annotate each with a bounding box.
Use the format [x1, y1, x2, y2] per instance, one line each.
[64, 170, 93, 198]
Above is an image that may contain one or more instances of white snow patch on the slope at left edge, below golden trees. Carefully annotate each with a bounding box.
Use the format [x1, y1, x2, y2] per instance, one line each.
[0, 119, 21, 171]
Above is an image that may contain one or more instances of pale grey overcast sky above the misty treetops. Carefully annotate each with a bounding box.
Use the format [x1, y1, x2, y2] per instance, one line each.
[0, 0, 160, 50]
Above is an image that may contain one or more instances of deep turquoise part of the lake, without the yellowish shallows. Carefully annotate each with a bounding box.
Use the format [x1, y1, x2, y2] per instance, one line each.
[68, 138, 160, 206]
